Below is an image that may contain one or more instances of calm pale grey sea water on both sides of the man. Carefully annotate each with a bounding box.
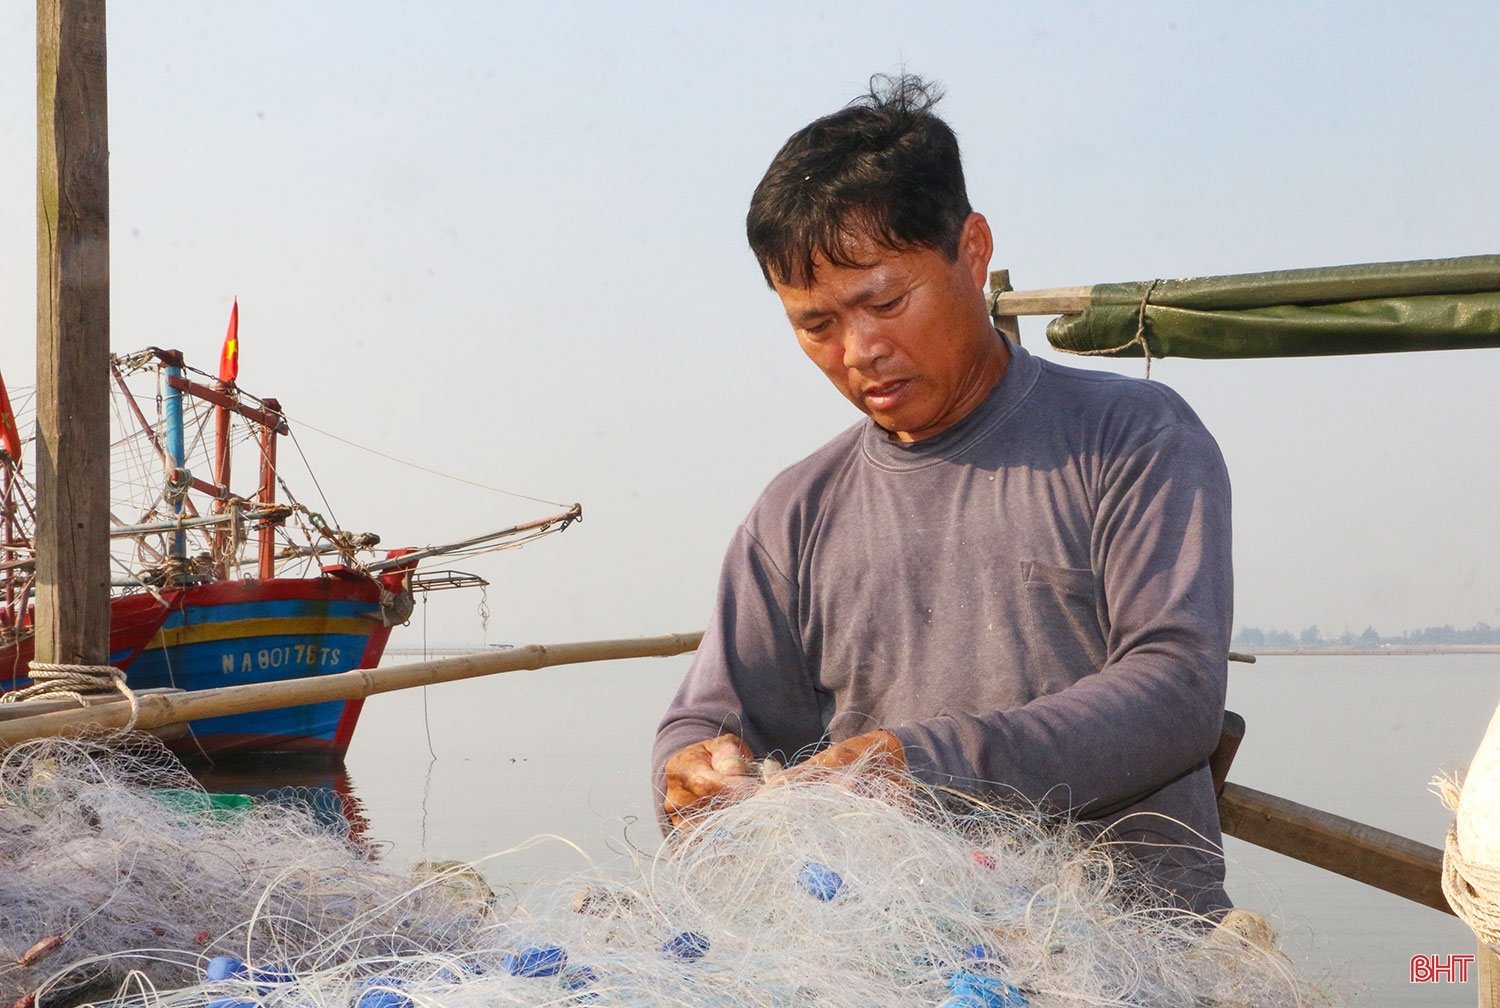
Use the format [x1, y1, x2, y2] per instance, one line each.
[205, 654, 1500, 1005]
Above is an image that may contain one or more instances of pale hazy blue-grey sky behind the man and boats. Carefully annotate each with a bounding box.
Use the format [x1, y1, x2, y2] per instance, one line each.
[0, 0, 1500, 647]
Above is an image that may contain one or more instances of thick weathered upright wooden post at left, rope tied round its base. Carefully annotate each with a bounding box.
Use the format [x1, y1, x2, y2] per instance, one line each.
[36, 0, 110, 665]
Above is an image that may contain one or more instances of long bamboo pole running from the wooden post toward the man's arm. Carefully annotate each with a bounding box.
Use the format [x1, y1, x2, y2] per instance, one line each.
[0, 633, 704, 749]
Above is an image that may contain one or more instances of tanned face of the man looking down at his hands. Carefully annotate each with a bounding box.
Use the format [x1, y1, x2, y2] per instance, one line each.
[774, 213, 1008, 441]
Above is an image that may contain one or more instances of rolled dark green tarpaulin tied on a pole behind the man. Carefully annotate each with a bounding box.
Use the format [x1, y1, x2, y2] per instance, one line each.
[1047, 255, 1500, 359]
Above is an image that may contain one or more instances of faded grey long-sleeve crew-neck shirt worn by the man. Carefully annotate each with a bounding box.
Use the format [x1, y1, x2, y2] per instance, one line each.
[653, 347, 1233, 912]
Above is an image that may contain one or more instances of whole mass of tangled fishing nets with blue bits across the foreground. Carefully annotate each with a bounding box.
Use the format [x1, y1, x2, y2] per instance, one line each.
[0, 732, 1329, 1008]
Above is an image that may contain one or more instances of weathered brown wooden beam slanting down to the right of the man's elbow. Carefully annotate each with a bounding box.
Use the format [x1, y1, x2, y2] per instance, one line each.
[1220, 783, 1454, 914]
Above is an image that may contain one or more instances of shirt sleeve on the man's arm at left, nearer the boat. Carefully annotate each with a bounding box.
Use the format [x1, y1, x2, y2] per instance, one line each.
[651, 525, 831, 798]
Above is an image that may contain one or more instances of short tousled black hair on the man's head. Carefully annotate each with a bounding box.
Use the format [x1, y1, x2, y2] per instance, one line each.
[746, 74, 971, 287]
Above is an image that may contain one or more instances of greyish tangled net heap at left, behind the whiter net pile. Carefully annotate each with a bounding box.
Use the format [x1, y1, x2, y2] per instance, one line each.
[0, 734, 491, 1004]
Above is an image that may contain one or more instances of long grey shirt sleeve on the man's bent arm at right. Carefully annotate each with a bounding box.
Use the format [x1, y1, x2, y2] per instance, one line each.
[891, 423, 1233, 818]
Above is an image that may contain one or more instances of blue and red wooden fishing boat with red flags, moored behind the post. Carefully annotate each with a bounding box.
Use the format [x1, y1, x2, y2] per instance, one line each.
[0, 333, 582, 759]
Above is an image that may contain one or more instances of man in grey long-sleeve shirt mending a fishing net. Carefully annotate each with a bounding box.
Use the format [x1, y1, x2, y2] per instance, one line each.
[653, 75, 1232, 915]
